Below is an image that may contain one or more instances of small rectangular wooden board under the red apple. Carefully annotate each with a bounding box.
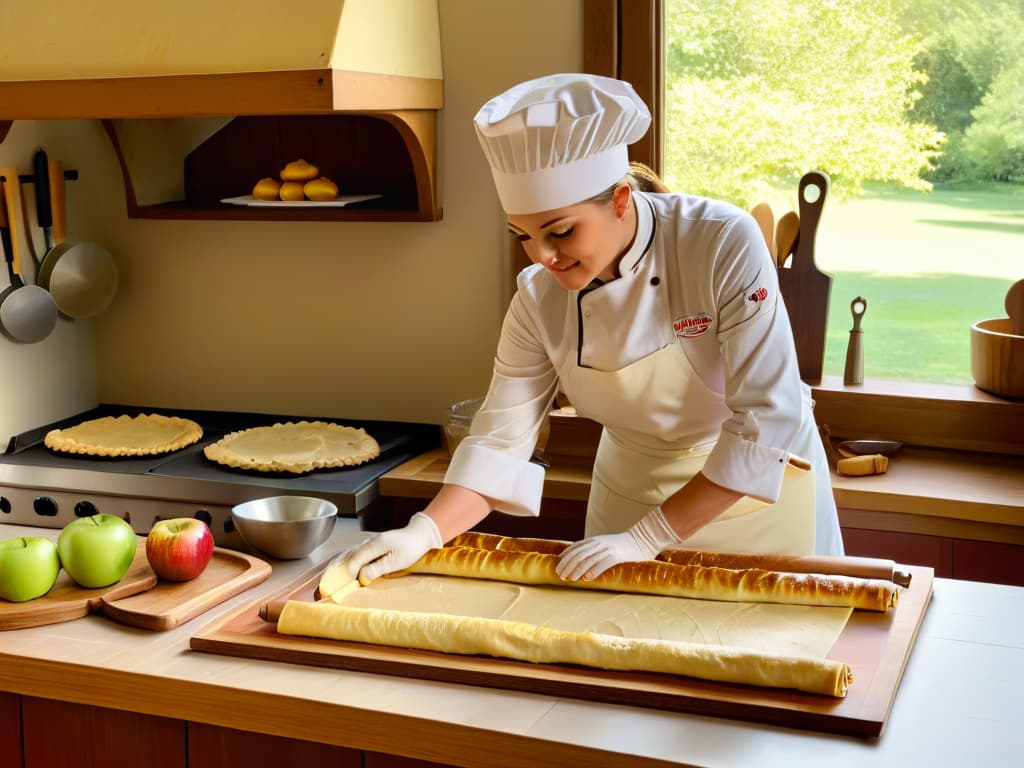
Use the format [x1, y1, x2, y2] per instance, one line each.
[99, 548, 270, 632]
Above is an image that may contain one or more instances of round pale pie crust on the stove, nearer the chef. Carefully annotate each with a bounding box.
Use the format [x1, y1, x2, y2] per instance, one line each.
[203, 421, 380, 473]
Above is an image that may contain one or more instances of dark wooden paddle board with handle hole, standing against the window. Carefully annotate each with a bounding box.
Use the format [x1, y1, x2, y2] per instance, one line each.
[778, 171, 831, 384]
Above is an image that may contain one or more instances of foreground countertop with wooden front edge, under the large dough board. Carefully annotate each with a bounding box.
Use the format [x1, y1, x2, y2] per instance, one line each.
[0, 519, 1024, 768]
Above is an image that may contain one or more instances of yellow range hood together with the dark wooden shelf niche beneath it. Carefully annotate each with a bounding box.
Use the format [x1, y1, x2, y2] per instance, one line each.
[0, 0, 443, 221]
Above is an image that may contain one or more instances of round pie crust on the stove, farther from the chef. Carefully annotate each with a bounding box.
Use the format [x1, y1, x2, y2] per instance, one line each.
[43, 414, 203, 457]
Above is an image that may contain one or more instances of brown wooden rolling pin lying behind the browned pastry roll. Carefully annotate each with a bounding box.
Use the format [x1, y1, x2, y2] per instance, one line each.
[449, 531, 911, 587]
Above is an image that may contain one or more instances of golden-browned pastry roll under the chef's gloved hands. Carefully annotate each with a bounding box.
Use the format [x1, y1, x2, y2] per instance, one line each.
[403, 547, 899, 611]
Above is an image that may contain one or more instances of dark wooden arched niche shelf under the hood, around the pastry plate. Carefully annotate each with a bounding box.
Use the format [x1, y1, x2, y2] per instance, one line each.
[103, 110, 441, 221]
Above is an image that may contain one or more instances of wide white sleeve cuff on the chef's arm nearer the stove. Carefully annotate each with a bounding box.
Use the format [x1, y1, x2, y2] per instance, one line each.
[444, 439, 544, 517]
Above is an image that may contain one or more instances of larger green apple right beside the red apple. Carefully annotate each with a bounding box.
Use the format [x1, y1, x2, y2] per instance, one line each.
[57, 514, 138, 589]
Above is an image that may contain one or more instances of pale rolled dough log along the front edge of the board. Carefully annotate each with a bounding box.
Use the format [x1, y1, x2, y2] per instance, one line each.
[278, 593, 851, 696]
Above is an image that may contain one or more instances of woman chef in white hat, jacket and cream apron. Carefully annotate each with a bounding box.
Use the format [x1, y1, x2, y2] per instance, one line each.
[343, 74, 843, 580]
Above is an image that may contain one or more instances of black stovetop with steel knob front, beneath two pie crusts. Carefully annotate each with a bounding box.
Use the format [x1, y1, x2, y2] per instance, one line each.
[0, 404, 440, 538]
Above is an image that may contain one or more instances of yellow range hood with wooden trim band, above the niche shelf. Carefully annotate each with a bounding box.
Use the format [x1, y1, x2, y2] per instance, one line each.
[0, 0, 442, 121]
